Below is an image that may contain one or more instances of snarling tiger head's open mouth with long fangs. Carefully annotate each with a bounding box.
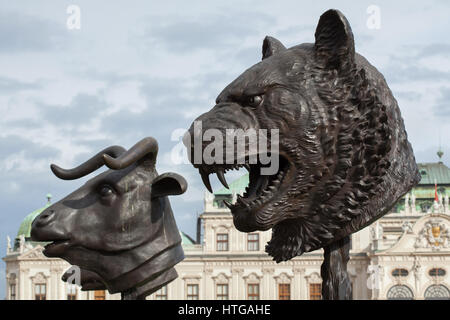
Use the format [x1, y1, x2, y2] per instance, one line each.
[196, 155, 293, 232]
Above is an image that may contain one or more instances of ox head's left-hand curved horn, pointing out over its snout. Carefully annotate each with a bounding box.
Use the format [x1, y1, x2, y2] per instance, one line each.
[50, 146, 126, 180]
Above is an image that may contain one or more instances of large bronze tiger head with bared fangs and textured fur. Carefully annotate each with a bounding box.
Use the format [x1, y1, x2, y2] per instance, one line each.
[183, 10, 420, 262]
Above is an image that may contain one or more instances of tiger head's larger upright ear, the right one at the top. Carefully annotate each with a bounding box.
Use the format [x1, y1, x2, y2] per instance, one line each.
[314, 10, 355, 70]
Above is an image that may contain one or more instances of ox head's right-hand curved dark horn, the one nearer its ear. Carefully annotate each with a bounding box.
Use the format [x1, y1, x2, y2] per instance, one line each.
[103, 137, 158, 170]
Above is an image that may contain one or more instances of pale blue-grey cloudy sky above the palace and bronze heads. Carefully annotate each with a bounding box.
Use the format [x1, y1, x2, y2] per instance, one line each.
[0, 0, 450, 298]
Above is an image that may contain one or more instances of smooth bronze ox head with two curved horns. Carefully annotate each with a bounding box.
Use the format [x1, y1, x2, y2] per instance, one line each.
[31, 137, 187, 299]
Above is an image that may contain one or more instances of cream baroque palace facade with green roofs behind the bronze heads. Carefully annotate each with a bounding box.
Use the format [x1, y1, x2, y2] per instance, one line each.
[3, 161, 450, 300]
